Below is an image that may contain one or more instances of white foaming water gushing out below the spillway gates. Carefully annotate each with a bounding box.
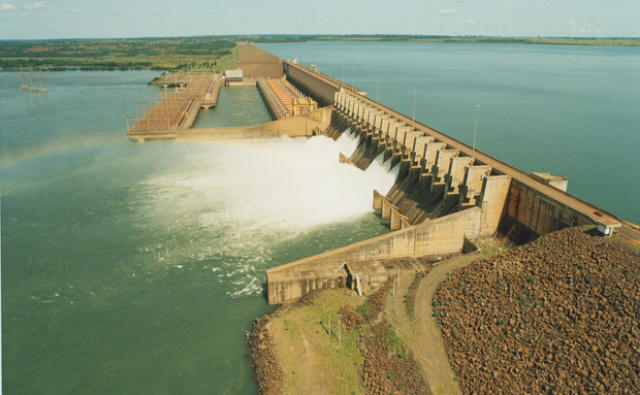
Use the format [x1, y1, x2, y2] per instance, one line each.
[142, 134, 396, 297]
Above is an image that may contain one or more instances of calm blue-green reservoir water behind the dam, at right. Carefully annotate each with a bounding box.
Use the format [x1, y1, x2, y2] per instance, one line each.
[259, 42, 640, 223]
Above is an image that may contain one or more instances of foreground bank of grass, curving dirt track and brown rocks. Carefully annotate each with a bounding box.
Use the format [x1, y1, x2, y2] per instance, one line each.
[248, 227, 640, 395]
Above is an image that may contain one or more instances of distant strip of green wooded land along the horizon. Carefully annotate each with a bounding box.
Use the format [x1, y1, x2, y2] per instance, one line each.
[0, 35, 640, 71]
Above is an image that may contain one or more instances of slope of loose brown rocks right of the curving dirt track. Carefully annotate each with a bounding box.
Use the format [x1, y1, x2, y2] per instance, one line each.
[433, 228, 640, 394]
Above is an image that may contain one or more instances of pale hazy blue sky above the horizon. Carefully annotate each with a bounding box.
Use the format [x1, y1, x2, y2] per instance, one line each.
[0, 0, 640, 40]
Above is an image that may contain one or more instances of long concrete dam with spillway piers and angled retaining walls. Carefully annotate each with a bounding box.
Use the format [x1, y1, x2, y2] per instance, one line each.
[129, 45, 640, 304]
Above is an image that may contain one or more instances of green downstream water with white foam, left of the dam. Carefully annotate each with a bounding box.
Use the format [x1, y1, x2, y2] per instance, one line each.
[0, 72, 393, 394]
